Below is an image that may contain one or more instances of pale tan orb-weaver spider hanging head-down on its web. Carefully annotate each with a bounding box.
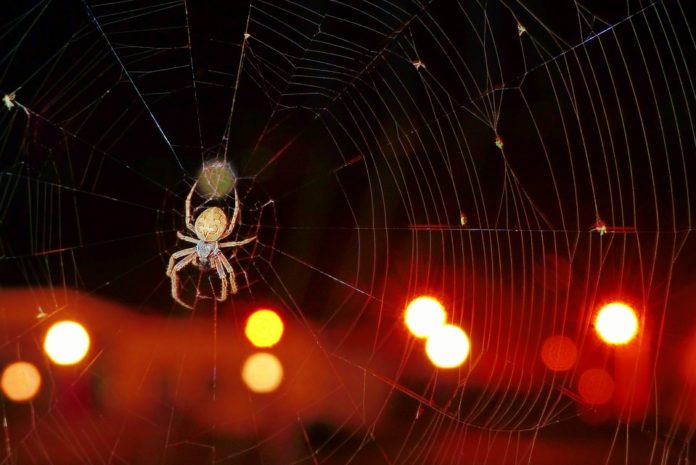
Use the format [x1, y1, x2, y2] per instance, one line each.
[167, 181, 256, 309]
